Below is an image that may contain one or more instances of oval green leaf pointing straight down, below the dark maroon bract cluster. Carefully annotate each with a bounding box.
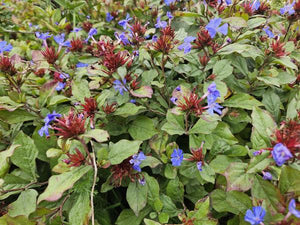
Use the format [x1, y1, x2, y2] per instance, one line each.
[126, 182, 148, 216]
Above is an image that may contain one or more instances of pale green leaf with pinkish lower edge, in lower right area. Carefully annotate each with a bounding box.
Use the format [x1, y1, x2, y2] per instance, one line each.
[224, 162, 254, 191]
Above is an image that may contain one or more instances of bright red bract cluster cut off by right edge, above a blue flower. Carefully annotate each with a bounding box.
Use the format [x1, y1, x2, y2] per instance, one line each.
[272, 117, 300, 155]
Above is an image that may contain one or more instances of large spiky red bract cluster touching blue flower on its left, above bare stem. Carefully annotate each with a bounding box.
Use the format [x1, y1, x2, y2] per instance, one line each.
[52, 109, 85, 139]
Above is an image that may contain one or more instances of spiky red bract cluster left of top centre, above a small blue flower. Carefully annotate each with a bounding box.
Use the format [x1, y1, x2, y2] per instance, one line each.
[102, 52, 129, 75]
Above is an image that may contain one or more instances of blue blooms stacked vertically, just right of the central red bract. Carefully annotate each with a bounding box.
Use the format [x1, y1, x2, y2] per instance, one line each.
[207, 82, 223, 115]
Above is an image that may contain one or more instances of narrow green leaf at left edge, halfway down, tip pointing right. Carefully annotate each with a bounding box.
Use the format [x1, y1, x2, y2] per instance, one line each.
[0, 109, 36, 124]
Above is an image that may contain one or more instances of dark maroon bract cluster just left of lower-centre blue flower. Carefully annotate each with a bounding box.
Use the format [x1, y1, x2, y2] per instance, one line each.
[111, 156, 140, 187]
